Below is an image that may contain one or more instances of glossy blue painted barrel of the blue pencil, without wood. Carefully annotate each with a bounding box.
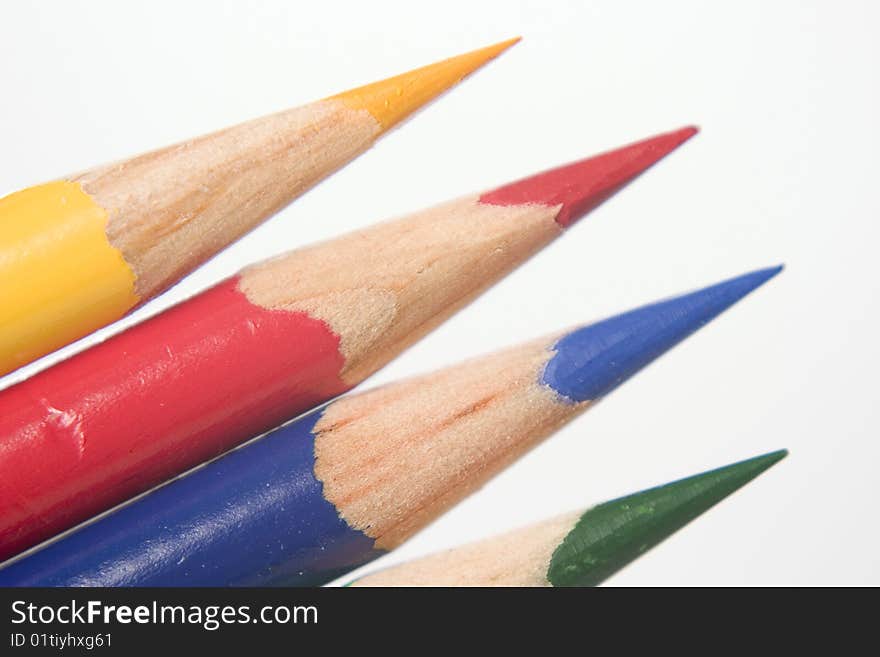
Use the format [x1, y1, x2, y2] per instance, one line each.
[0, 412, 379, 586]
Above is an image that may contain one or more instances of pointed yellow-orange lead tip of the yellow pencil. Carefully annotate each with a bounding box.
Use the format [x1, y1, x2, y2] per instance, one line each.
[331, 37, 520, 130]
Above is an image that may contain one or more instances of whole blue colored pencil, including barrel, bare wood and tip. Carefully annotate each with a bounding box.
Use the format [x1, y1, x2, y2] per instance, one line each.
[0, 268, 779, 586]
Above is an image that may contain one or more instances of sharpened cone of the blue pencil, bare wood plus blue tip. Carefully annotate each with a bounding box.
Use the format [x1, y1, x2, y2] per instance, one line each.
[314, 268, 779, 550]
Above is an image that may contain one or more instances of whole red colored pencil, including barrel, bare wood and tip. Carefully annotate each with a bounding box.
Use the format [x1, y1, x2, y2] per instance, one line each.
[0, 128, 694, 560]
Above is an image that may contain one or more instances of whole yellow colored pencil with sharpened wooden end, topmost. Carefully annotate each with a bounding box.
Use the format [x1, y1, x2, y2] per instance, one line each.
[0, 39, 518, 374]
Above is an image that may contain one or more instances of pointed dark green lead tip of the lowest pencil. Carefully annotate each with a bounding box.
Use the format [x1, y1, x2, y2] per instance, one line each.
[547, 449, 788, 586]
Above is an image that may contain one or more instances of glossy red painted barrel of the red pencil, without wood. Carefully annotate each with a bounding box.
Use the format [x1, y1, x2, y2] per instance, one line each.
[0, 278, 346, 558]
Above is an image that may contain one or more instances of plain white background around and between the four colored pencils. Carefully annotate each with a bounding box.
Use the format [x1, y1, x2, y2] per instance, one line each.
[0, 0, 880, 585]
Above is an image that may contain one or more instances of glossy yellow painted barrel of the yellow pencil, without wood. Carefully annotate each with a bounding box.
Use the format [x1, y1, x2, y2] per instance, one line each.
[0, 181, 138, 375]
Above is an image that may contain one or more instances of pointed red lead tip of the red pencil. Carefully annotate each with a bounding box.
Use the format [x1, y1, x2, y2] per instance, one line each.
[480, 126, 697, 227]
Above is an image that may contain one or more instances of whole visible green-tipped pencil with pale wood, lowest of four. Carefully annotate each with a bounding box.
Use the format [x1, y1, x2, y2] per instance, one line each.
[350, 450, 788, 586]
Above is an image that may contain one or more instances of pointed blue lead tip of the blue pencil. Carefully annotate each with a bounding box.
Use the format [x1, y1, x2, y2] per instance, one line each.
[542, 265, 782, 402]
